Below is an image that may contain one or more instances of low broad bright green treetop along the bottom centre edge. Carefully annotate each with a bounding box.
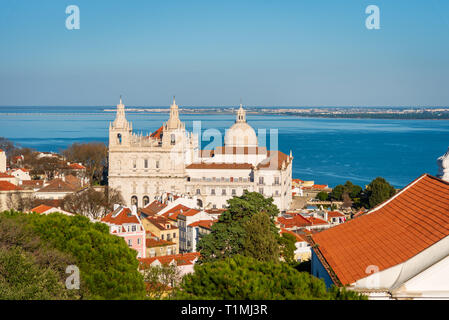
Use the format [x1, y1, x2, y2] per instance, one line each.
[177, 255, 364, 300]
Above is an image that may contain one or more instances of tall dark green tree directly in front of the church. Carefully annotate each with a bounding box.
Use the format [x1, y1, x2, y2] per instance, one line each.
[198, 190, 279, 262]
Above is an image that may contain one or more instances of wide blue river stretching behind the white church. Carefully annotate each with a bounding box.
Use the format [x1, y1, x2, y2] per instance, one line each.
[0, 107, 449, 187]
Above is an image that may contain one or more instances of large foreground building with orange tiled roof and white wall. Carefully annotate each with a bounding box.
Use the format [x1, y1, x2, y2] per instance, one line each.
[312, 174, 449, 299]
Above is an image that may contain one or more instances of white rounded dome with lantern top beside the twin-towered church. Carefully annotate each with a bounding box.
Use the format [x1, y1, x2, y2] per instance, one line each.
[224, 105, 258, 147]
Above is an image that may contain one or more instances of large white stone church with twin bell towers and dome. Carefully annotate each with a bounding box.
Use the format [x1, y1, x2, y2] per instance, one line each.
[108, 99, 293, 211]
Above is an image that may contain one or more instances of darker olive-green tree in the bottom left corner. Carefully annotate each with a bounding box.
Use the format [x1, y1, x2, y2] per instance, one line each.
[0, 212, 80, 300]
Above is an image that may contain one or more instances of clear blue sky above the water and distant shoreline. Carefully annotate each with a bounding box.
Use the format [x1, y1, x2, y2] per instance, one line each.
[0, 0, 449, 106]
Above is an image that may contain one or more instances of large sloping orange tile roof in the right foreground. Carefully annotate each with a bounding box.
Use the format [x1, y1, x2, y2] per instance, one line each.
[313, 174, 449, 285]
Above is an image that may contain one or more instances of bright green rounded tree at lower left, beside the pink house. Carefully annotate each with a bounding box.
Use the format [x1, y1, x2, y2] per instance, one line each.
[19, 213, 145, 299]
